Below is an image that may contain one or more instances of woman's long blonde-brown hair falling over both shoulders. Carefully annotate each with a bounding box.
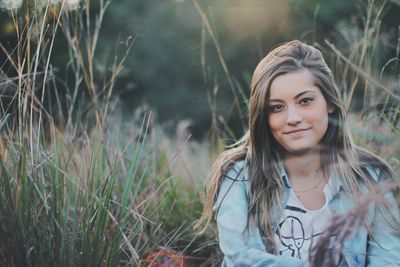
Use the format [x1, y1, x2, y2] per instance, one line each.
[196, 40, 393, 250]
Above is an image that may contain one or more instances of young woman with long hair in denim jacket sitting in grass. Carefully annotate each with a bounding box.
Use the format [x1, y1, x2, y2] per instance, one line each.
[198, 41, 400, 266]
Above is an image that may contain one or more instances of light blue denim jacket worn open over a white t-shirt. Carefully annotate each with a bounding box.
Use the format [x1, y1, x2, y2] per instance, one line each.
[214, 161, 400, 267]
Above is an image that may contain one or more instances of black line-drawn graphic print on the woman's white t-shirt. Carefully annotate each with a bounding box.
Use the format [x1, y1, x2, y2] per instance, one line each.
[276, 205, 322, 259]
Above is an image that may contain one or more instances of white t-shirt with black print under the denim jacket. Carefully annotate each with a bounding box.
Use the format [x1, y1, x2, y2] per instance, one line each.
[275, 179, 335, 261]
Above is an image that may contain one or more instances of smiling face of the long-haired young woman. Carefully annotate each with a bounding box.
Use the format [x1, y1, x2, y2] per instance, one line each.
[268, 70, 333, 154]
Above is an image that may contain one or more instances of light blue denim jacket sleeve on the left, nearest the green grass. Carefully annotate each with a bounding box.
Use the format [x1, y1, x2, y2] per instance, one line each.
[214, 165, 308, 267]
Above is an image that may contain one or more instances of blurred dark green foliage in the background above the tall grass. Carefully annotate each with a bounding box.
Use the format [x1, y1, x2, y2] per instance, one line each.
[0, 0, 400, 137]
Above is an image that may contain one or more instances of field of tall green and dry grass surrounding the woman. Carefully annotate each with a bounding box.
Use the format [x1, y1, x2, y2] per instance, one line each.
[0, 0, 400, 266]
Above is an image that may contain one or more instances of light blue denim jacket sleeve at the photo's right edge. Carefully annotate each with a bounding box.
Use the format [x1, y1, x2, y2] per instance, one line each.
[367, 189, 400, 267]
